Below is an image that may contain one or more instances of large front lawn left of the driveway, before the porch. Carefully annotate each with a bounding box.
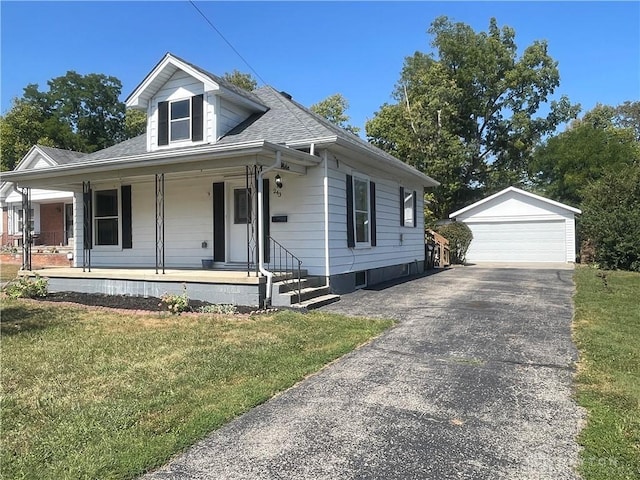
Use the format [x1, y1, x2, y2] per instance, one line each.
[0, 298, 392, 480]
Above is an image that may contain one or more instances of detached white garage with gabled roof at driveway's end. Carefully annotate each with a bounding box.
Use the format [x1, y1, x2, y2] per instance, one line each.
[449, 187, 582, 263]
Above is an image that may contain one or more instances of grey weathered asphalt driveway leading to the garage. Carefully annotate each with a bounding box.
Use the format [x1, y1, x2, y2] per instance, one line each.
[145, 267, 583, 480]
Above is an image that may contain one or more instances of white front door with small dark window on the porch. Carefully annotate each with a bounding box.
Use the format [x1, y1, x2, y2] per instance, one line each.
[227, 184, 255, 263]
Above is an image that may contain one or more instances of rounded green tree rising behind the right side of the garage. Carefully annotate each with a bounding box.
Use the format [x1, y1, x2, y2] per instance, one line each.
[531, 102, 640, 205]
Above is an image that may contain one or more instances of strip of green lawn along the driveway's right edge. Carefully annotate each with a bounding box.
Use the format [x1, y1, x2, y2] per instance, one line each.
[574, 267, 640, 480]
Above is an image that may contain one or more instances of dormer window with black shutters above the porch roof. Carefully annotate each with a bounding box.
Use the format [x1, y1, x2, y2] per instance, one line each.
[158, 95, 204, 146]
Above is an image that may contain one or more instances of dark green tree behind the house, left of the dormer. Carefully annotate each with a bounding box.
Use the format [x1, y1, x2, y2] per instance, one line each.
[0, 71, 146, 170]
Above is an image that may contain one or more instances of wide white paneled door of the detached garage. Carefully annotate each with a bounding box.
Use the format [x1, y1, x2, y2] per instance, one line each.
[467, 220, 566, 263]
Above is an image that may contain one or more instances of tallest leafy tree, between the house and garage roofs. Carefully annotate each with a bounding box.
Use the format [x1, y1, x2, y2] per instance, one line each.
[366, 17, 578, 216]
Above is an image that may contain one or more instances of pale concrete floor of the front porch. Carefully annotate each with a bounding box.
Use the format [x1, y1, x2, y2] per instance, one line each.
[21, 267, 264, 285]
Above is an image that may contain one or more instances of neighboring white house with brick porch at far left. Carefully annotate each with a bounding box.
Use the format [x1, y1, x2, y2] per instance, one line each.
[0, 145, 86, 247]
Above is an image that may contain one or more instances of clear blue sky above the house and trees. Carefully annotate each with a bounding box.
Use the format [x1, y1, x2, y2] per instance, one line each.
[0, 0, 640, 135]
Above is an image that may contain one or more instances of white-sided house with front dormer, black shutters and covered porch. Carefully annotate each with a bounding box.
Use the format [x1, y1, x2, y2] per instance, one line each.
[4, 54, 438, 304]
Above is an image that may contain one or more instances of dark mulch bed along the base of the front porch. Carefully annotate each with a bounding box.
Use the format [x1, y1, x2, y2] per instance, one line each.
[35, 292, 257, 313]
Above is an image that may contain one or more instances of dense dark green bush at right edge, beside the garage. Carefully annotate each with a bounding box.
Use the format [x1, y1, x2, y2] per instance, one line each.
[580, 164, 640, 272]
